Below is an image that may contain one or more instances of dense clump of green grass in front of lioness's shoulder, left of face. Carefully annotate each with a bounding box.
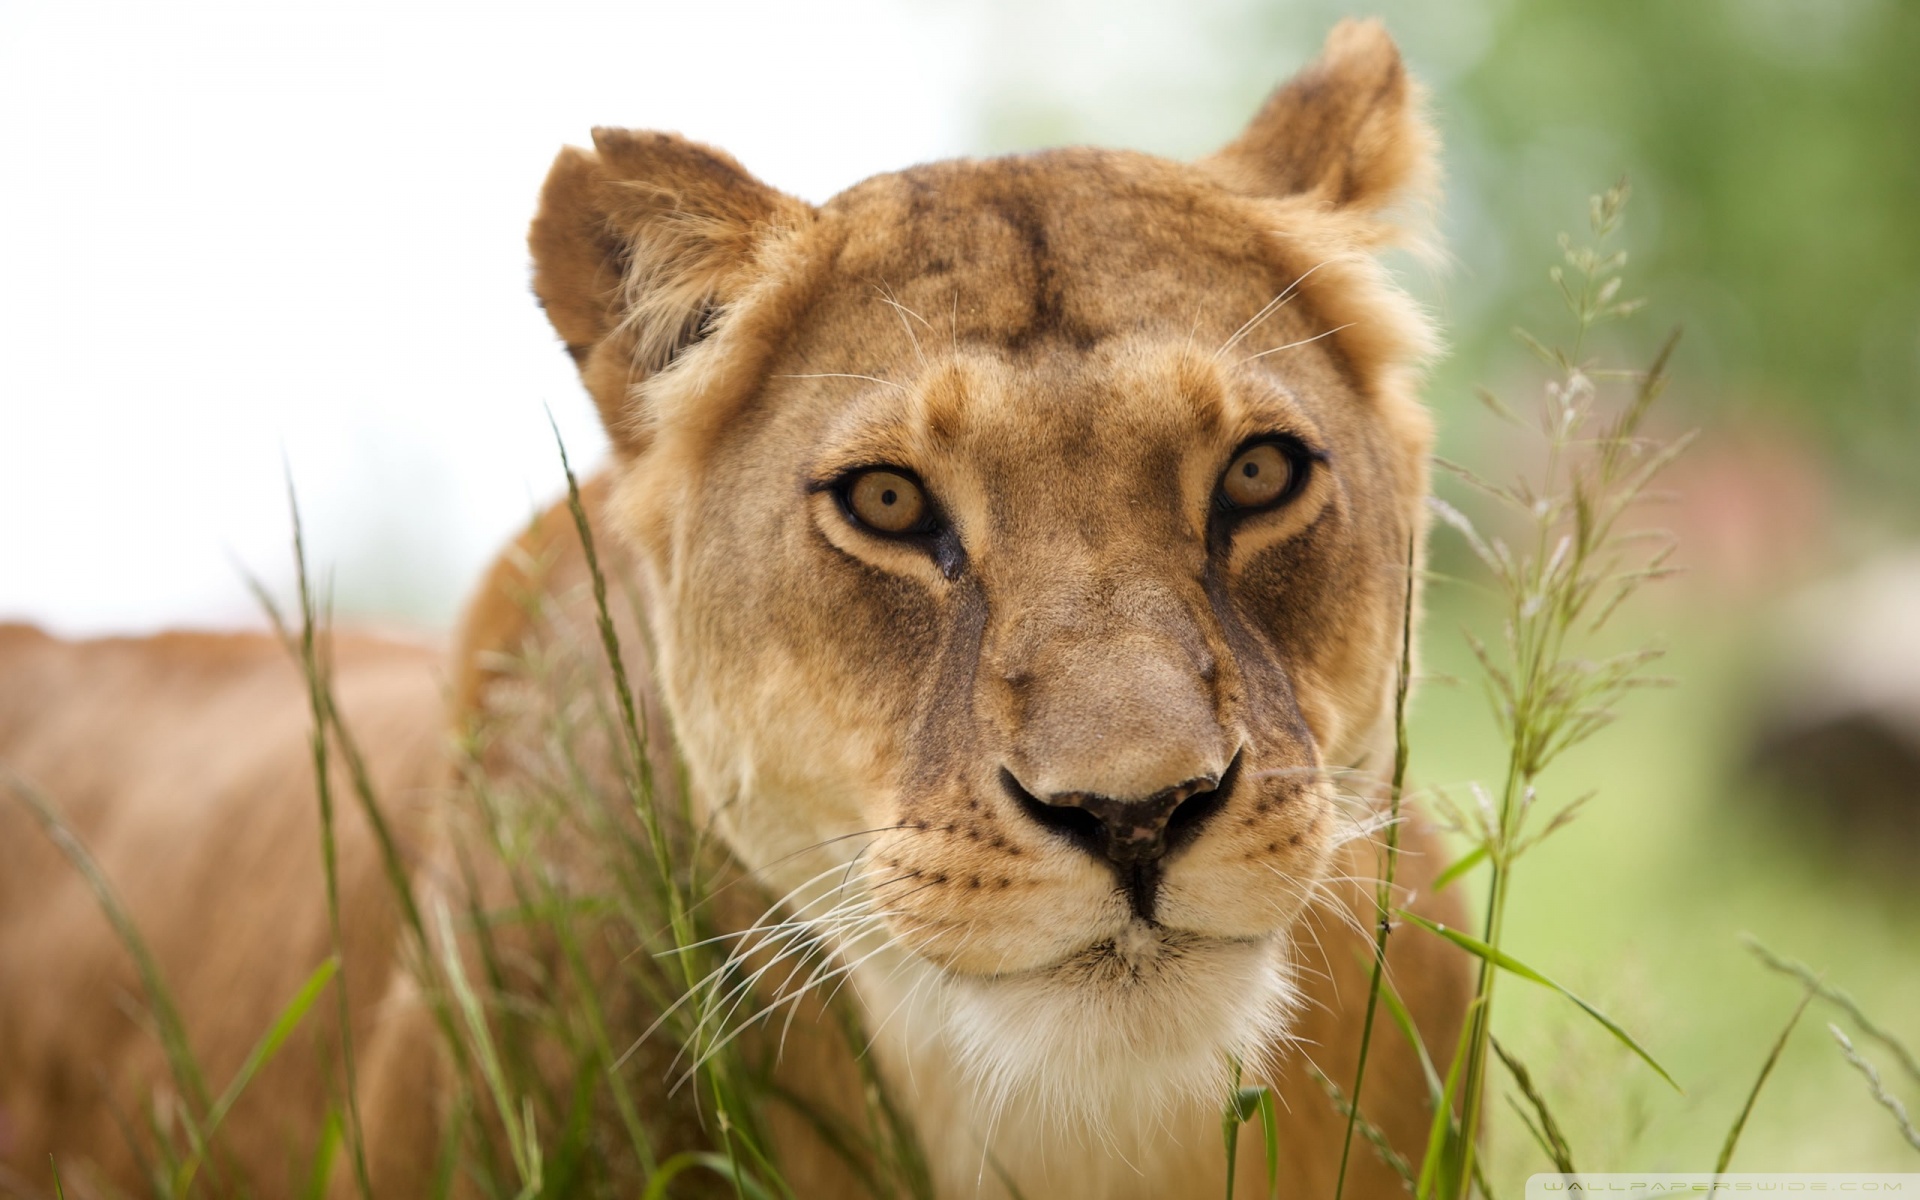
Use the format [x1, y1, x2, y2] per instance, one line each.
[309, 441, 931, 1200]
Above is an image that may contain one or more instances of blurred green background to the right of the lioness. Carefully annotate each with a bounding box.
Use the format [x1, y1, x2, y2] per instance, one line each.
[979, 0, 1920, 1194]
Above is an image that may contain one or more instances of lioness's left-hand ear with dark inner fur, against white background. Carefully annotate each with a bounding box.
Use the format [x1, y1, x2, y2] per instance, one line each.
[528, 129, 814, 451]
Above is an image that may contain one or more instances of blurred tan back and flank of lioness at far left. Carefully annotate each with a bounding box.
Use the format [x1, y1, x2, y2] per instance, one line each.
[0, 626, 447, 1194]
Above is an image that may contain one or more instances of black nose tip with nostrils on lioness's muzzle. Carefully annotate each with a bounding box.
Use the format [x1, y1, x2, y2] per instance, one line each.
[1000, 755, 1240, 916]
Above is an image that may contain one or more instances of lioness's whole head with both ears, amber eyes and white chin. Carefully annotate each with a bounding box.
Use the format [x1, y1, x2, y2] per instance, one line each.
[534, 16, 1427, 1121]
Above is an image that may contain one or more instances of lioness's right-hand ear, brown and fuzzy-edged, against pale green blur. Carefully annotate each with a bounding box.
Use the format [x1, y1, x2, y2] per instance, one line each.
[1200, 19, 1434, 236]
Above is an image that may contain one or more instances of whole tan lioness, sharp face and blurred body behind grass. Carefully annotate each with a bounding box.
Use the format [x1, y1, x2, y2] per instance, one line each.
[0, 23, 1467, 1198]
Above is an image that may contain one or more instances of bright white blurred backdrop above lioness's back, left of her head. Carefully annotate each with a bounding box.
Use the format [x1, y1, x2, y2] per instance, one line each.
[0, 0, 983, 634]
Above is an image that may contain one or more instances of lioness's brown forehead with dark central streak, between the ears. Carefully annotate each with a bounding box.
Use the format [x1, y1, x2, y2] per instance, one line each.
[828, 150, 1332, 370]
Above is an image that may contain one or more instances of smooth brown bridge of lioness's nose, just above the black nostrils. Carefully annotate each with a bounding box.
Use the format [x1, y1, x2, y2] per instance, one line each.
[996, 564, 1233, 799]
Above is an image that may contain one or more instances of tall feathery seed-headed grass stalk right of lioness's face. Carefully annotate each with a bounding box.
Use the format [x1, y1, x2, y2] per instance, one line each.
[1428, 182, 1688, 1200]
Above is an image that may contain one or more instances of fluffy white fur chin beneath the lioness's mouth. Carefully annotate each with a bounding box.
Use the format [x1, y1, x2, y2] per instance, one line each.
[945, 922, 1298, 1139]
